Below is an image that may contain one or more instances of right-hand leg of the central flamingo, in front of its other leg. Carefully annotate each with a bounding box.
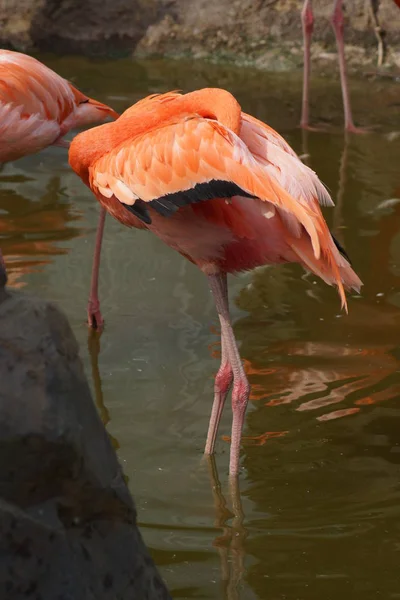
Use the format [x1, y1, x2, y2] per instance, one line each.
[208, 273, 250, 476]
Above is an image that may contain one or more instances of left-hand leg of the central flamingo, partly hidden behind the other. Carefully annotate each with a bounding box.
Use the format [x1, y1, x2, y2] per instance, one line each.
[204, 273, 233, 454]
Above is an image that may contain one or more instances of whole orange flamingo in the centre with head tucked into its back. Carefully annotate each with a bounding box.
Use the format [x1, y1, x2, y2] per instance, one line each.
[69, 88, 361, 477]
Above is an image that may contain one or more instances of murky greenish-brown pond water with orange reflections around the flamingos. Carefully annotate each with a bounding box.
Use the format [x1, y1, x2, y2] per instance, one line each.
[0, 56, 400, 600]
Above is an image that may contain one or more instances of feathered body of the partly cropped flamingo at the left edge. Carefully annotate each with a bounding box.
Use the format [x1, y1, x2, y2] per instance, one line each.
[0, 50, 119, 278]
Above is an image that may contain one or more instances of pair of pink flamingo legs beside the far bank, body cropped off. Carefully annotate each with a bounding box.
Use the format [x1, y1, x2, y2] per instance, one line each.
[300, 0, 400, 133]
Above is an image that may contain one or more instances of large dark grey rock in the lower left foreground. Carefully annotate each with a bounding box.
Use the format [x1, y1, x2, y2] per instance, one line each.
[0, 289, 170, 600]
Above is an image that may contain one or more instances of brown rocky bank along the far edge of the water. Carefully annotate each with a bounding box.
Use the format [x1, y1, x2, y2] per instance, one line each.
[0, 0, 400, 70]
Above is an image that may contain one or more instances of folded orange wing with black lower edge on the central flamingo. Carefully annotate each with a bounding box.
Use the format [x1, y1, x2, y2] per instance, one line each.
[89, 117, 326, 258]
